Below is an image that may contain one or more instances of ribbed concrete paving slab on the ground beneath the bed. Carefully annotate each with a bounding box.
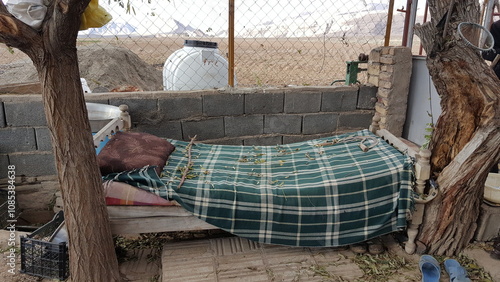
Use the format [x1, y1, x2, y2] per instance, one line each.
[162, 237, 363, 281]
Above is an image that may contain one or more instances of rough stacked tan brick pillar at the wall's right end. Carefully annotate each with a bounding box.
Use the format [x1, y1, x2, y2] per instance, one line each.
[368, 46, 412, 137]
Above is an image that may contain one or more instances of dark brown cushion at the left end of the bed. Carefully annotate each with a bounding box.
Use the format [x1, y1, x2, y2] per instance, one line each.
[97, 132, 175, 175]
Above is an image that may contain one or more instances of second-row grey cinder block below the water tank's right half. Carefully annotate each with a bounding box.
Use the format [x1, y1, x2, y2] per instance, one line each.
[182, 117, 224, 141]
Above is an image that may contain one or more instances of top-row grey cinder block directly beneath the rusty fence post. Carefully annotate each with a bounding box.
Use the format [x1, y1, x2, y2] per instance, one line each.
[203, 93, 245, 117]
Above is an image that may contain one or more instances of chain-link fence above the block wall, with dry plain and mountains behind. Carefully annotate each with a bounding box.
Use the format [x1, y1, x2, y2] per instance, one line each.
[0, 0, 422, 90]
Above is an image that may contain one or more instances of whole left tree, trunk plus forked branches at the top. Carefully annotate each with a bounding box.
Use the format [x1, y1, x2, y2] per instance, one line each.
[0, 0, 121, 281]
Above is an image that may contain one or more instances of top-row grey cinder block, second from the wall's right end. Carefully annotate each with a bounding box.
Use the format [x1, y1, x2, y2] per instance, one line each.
[321, 87, 358, 112]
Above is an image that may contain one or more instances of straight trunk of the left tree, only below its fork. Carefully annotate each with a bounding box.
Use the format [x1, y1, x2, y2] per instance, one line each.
[40, 48, 119, 281]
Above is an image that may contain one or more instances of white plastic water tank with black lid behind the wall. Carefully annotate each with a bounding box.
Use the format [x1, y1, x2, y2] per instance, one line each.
[163, 40, 236, 90]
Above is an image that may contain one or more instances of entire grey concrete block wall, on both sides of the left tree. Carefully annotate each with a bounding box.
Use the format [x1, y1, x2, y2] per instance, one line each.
[0, 86, 377, 223]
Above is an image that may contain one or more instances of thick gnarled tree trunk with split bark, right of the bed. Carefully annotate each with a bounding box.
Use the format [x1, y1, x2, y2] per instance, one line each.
[415, 0, 500, 255]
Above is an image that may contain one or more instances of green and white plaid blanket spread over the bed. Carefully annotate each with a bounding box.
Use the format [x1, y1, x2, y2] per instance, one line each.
[106, 130, 413, 246]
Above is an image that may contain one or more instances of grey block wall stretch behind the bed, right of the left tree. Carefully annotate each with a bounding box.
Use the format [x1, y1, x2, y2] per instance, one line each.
[105, 86, 377, 145]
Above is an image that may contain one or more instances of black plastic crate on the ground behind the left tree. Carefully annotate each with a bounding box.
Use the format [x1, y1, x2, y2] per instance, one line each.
[21, 211, 69, 280]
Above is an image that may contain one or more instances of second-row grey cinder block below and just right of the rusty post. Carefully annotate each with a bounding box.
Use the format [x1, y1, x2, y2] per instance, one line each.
[224, 115, 264, 137]
